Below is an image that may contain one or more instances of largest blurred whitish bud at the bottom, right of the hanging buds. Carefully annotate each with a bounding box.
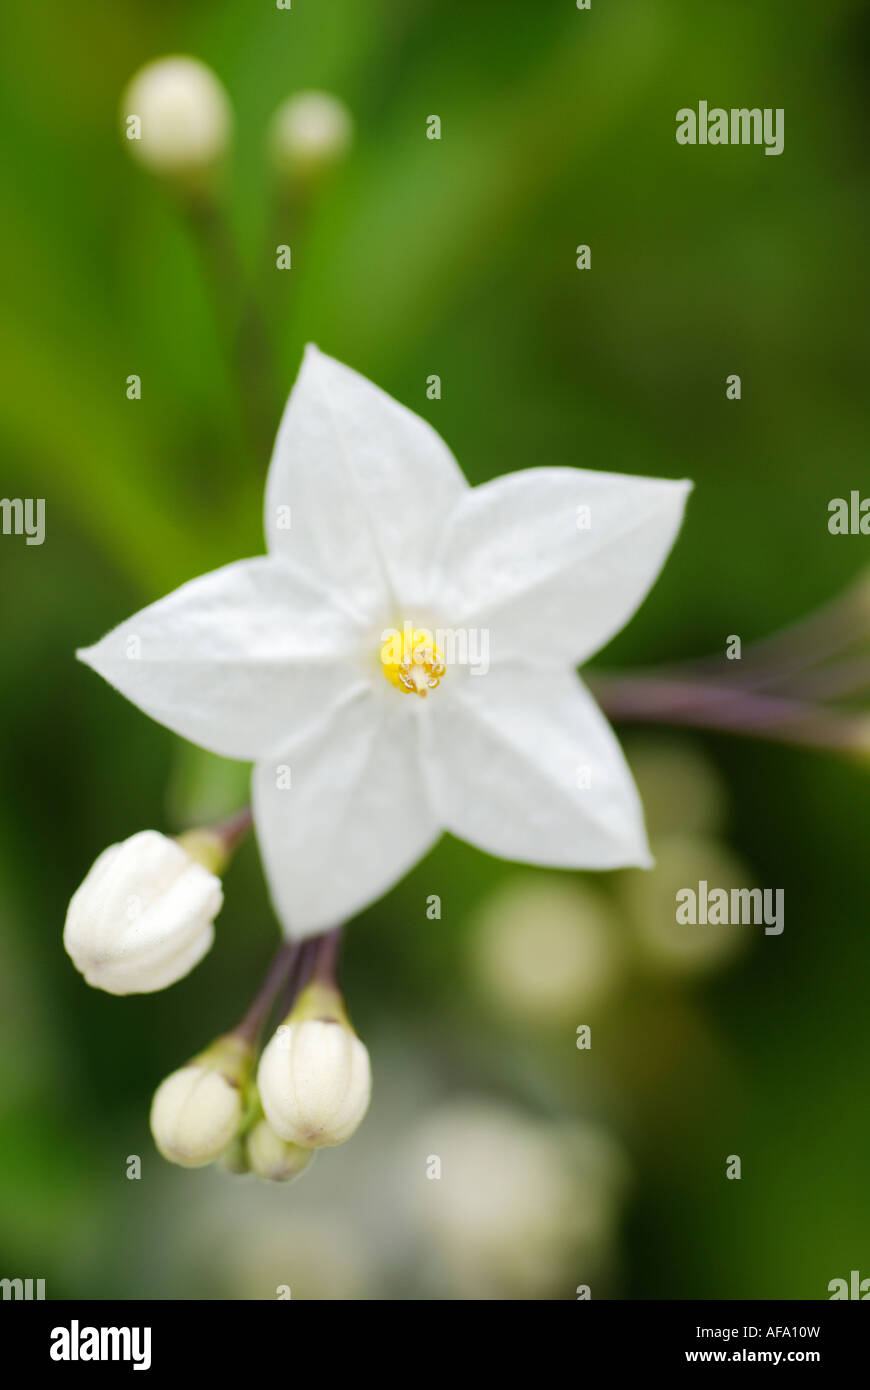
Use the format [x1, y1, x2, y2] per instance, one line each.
[403, 1098, 625, 1298]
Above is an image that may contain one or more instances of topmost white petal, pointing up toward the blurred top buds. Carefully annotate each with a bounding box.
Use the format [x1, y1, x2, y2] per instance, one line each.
[265, 346, 467, 617]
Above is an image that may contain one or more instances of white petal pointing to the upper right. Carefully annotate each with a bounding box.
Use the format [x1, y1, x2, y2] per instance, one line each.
[434, 468, 691, 666]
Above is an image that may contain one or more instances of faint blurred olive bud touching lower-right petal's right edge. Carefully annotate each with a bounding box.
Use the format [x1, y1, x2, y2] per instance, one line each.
[625, 734, 728, 840]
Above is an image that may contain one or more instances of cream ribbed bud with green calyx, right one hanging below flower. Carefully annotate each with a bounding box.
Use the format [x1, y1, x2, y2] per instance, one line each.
[257, 984, 371, 1148]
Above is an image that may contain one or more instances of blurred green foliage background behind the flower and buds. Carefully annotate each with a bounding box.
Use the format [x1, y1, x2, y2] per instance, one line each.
[0, 0, 870, 1298]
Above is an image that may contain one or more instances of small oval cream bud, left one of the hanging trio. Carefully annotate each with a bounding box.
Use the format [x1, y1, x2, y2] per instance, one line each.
[150, 1062, 242, 1168]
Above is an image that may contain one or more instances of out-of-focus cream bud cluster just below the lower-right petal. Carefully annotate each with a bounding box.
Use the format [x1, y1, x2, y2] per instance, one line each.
[470, 737, 755, 1030]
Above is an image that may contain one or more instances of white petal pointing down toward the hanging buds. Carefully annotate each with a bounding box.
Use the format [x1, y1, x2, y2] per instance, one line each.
[253, 682, 439, 938]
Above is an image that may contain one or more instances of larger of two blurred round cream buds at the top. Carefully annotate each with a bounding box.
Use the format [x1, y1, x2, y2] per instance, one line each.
[121, 56, 232, 174]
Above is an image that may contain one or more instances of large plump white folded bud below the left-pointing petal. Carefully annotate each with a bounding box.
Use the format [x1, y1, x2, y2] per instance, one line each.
[64, 830, 224, 994]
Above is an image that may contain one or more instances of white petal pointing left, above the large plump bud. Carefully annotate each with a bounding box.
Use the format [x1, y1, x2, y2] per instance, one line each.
[78, 556, 364, 760]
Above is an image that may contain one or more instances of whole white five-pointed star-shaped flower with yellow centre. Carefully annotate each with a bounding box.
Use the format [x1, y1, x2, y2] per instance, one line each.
[79, 348, 691, 937]
